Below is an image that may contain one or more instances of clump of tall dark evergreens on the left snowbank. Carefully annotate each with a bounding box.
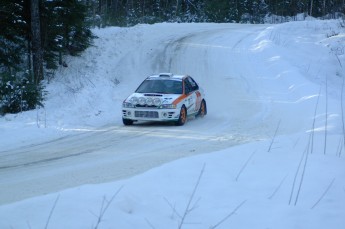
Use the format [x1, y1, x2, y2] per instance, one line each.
[0, 0, 93, 114]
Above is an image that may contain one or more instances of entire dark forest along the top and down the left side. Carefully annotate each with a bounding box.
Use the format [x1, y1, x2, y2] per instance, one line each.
[0, 0, 345, 115]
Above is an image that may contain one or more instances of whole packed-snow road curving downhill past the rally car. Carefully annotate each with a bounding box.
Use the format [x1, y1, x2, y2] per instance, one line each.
[0, 24, 322, 204]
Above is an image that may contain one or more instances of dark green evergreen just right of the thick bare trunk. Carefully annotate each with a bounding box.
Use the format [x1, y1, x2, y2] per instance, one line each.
[41, 0, 93, 69]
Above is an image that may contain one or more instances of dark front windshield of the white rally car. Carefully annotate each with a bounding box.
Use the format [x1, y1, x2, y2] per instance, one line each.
[135, 79, 182, 94]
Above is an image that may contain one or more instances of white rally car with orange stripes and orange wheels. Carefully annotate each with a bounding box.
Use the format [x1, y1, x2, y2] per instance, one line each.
[122, 73, 207, 126]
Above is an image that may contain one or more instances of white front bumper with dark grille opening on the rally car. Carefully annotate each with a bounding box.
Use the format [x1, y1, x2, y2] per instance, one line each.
[122, 108, 180, 122]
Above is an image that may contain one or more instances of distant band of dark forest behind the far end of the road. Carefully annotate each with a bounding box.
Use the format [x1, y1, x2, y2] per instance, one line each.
[95, 0, 345, 26]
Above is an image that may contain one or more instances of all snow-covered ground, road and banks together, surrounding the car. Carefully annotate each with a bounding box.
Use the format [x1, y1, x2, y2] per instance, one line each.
[0, 20, 345, 229]
